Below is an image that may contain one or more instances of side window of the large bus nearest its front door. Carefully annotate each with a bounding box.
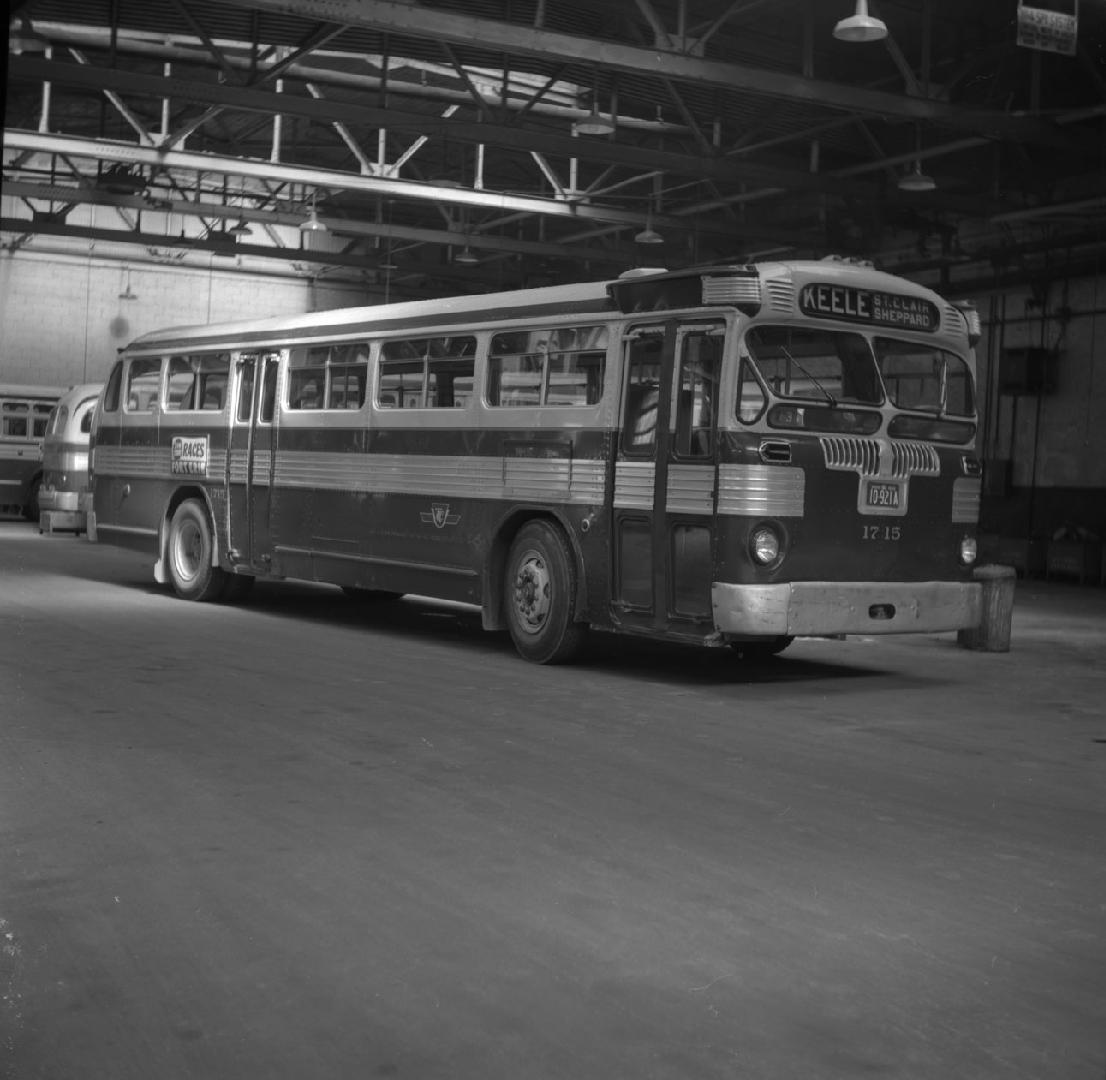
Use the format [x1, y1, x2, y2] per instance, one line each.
[488, 326, 607, 408]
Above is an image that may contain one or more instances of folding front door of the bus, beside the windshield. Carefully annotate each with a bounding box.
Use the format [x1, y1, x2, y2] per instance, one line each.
[612, 320, 726, 637]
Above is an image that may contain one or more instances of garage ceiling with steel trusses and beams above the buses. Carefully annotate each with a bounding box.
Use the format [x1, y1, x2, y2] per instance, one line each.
[0, 0, 1106, 295]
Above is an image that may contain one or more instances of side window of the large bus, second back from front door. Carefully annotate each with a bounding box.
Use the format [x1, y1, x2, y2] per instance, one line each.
[376, 334, 477, 408]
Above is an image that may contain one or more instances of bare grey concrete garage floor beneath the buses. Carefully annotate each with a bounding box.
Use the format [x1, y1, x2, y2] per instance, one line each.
[0, 521, 1106, 1080]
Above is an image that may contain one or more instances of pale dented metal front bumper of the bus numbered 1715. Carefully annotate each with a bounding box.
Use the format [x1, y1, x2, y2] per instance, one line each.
[711, 581, 982, 637]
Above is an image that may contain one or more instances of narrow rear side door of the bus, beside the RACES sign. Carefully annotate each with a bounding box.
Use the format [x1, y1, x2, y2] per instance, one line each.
[227, 353, 280, 573]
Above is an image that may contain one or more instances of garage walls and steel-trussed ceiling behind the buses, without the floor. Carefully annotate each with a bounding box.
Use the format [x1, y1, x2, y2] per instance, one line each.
[0, 0, 1106, 581]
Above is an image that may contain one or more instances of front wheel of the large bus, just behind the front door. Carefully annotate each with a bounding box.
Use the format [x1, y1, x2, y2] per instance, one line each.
[503, 521, 587, 664]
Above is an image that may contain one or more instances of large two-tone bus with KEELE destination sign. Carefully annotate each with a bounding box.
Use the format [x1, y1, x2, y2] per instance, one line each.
[88, 259, 981, 663]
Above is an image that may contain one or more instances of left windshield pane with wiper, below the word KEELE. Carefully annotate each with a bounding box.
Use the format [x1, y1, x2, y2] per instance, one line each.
[745, 326, 884, 405]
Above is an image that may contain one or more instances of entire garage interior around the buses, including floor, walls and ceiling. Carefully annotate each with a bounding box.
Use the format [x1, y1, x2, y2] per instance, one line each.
[0, 0, 1106, 1080]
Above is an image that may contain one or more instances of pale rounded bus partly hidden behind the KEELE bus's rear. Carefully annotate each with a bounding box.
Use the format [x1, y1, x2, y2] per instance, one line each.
[39, 383, 103, 533]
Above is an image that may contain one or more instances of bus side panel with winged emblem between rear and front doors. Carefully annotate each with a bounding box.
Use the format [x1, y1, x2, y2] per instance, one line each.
[266, 425, 608, 616]
